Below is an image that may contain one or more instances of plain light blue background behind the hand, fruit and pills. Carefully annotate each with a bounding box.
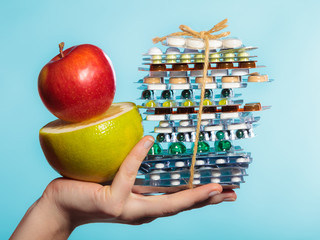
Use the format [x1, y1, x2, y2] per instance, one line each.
[0, 0, 320, 239]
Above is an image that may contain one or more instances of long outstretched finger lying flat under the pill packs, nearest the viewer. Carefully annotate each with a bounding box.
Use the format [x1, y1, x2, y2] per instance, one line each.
[135, 183, 222, 217]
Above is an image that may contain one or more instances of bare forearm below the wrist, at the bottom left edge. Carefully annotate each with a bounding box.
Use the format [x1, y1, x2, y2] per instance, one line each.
[10, 197, 74, 240]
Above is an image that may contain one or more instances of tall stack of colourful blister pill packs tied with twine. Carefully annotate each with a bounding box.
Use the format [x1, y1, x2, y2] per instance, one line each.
[136, 36, 272, 192]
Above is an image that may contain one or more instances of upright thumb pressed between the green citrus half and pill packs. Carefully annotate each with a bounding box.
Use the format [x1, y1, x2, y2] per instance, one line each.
[111, 136, 154, 201]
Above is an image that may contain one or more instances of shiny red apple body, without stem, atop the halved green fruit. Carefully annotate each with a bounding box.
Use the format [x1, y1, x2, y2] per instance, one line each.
[38, 44, 116, 122]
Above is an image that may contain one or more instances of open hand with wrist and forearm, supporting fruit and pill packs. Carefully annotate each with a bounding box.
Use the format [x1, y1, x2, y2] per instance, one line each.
[12, 136, 236, 239]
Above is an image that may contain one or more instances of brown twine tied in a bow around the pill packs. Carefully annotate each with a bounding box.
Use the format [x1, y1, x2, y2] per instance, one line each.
[152, 19, 230, 188]
